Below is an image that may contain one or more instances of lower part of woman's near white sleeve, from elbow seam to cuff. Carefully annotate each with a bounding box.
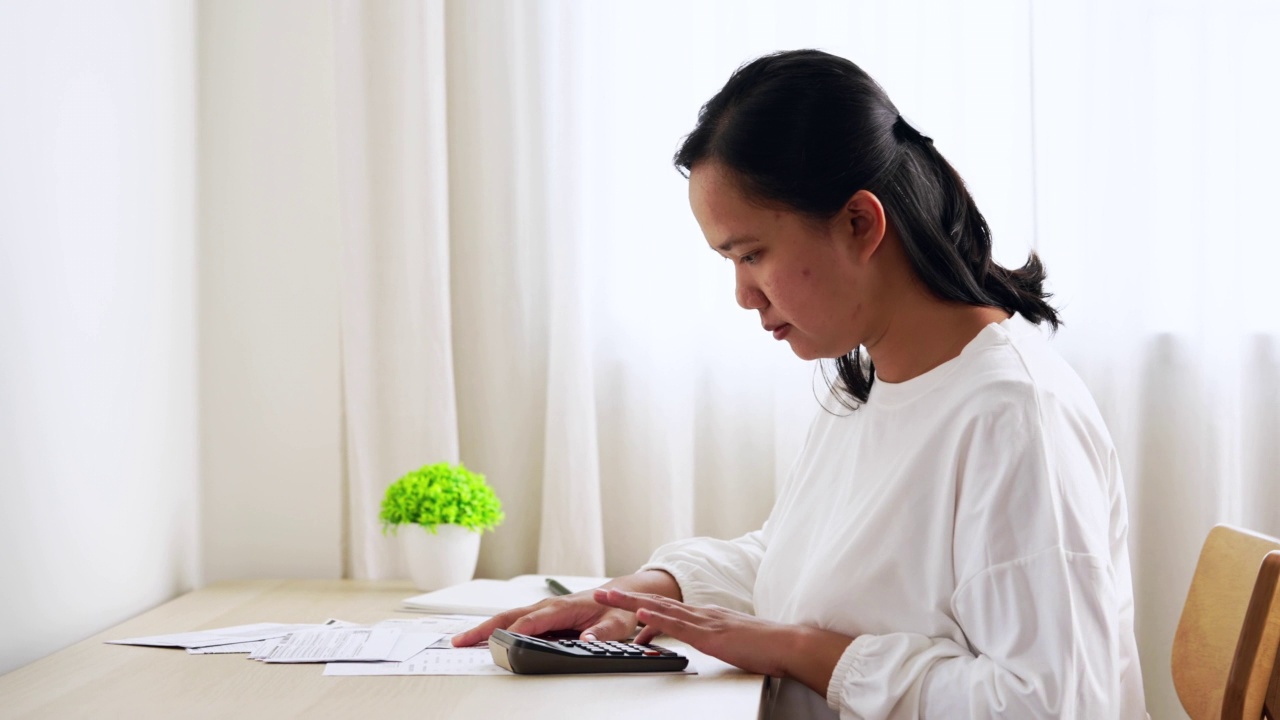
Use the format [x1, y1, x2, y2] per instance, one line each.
[827, 548, 1119, 720]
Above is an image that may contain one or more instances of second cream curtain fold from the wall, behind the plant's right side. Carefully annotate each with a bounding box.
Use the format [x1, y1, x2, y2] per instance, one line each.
[445, 0, 552, 578]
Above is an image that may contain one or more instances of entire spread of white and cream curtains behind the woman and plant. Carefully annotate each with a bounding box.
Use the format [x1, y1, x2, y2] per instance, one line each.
[335, 0, 1280, 717]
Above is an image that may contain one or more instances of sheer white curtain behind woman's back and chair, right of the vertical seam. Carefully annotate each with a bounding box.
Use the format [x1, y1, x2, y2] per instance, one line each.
[1032, 0, 1280, 717]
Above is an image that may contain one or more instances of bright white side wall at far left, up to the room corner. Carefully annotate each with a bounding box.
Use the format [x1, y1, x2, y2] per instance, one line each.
[0, 0, 198, 673]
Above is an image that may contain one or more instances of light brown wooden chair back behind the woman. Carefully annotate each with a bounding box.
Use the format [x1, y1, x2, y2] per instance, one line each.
[1172, 525, 1280, 720]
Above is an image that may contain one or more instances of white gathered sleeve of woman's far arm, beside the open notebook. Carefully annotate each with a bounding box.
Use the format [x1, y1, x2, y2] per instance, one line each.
[640, 529, 764, 614]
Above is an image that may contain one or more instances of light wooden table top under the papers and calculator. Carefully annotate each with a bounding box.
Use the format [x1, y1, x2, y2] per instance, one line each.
[0, 580, 763, 720]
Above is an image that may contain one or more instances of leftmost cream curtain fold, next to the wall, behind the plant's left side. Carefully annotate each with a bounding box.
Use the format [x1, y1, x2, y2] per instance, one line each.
[335, 0, 458, 578]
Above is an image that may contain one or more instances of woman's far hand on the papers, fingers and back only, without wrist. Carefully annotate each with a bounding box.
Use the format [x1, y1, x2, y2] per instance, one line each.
[453, 591, 637, 647]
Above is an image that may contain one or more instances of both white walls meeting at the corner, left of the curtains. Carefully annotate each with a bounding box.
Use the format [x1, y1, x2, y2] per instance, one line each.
[0, 0, 343, 673]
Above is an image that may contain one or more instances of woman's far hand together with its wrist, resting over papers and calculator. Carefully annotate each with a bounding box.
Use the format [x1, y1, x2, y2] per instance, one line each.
[453, 570, 681, 647]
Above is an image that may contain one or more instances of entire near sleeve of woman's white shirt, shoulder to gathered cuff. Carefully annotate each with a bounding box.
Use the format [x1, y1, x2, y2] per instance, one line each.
[827, 384, 1123, 720]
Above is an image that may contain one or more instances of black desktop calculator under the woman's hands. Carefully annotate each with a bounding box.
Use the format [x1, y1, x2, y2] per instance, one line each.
[489, 630, 689, 675]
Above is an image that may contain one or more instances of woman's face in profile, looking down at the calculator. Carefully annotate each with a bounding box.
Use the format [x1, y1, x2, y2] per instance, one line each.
[689, 163, 883, 360]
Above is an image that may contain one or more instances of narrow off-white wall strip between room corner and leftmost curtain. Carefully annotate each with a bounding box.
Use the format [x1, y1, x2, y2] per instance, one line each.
[197, 0, 343, 582]
